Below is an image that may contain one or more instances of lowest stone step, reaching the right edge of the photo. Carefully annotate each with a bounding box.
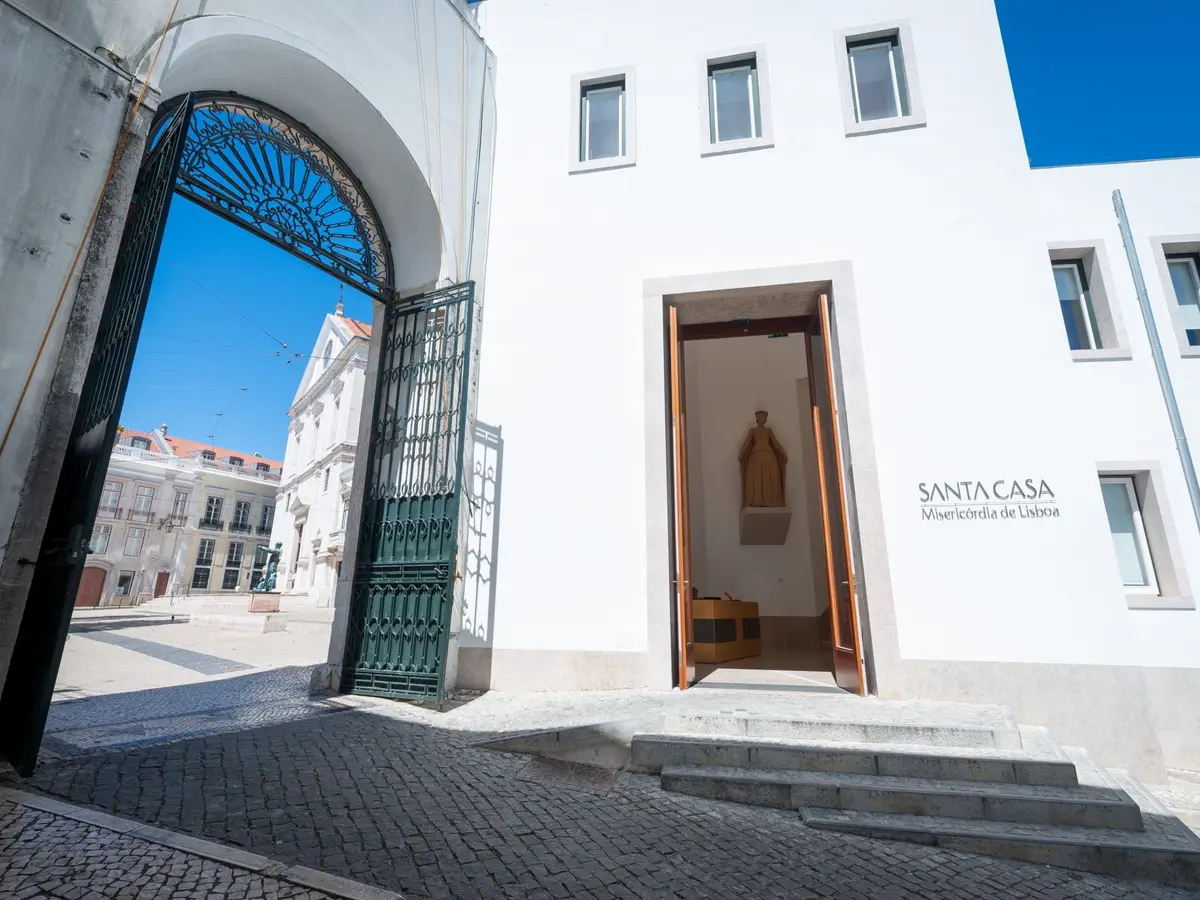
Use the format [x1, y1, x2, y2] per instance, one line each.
[800, 808, 1200, 889]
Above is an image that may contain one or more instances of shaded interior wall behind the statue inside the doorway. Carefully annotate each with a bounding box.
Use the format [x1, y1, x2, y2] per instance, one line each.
[684, 335, 827, 624]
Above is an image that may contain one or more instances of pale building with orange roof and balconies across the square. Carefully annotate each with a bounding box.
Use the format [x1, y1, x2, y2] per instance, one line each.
[76, 425, 283, 607]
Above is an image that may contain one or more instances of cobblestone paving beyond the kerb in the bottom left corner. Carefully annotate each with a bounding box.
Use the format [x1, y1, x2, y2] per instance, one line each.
[0, 800, 328, 900]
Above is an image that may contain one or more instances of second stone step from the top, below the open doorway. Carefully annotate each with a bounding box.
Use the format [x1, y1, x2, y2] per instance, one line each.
[630, 734, 1078, 787]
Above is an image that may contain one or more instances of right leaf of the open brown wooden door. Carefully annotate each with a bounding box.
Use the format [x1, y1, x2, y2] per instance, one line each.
[808, 294, 865, 694]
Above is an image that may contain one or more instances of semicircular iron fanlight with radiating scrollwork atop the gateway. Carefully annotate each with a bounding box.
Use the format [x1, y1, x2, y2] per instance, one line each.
[155, 92, 391, 295]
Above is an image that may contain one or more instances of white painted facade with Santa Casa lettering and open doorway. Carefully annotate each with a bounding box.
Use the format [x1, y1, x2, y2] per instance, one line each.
[461, 0, 1200, 772]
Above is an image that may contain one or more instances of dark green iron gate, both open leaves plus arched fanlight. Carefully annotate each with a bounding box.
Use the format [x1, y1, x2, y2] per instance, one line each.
[0, 92, 474, 773]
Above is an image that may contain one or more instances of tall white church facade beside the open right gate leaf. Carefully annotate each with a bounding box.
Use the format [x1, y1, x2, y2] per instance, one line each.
[271, 302, 371, 606]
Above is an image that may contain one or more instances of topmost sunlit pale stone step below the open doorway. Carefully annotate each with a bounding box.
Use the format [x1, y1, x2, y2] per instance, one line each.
[661, 713, 1021, 750]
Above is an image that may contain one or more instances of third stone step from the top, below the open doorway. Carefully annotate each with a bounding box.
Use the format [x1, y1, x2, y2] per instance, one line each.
[661, 766, 1142, 830]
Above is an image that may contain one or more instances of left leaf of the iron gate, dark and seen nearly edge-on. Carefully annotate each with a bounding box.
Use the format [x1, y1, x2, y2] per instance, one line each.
[0, 97, 192, 775]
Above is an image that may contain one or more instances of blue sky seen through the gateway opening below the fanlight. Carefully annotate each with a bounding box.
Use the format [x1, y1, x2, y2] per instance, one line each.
[121, 200, 372, 460]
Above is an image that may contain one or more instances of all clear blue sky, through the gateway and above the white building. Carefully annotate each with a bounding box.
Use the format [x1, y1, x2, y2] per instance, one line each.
[121, 0, 1200, 458]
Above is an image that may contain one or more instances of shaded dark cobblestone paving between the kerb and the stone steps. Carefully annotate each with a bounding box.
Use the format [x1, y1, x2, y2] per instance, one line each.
[25, 709, 1194, 900]
